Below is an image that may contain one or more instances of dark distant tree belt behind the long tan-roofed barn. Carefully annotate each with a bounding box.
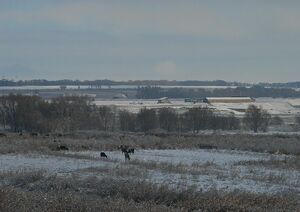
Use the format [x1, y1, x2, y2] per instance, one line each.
[136, 86, 300, 99]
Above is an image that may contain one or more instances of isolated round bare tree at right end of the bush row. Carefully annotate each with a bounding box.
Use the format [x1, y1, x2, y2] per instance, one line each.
[244, 105, 271, 132]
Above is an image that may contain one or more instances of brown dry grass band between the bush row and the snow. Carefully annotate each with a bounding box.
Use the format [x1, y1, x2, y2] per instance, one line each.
[0, 132, 300, 155]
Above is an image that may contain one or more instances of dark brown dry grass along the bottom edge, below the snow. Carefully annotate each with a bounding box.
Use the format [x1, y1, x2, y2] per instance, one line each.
[0, 172, 300, 211]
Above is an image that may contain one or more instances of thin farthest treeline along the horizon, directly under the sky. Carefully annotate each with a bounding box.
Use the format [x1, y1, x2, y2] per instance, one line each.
[0, 79, 300, 88]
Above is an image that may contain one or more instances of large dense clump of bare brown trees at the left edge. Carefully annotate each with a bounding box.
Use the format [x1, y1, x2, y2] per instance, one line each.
[0, 95, 115, 133]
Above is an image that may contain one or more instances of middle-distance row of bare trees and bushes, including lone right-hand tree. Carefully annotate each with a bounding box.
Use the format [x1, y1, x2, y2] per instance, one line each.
[0, 94, 282, 133]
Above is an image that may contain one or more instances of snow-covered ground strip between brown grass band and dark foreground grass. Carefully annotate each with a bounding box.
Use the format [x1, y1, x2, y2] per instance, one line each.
[0, 150, 300, 195]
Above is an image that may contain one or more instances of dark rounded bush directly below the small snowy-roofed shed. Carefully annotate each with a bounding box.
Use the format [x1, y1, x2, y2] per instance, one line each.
[158, 108, 178, 132]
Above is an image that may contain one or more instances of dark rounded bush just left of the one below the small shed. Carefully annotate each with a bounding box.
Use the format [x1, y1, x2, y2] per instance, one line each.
[137, 108, 157, 132]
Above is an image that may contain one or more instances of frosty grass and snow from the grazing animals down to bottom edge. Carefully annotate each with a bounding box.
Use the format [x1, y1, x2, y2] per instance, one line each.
[0, 149, 300, 211]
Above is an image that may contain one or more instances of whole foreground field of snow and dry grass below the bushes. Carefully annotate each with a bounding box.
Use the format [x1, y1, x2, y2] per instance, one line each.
[0, 133, 300, 211]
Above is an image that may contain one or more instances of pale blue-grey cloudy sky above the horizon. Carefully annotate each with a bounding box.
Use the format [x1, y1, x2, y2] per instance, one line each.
[0, 0, 300, 82]
